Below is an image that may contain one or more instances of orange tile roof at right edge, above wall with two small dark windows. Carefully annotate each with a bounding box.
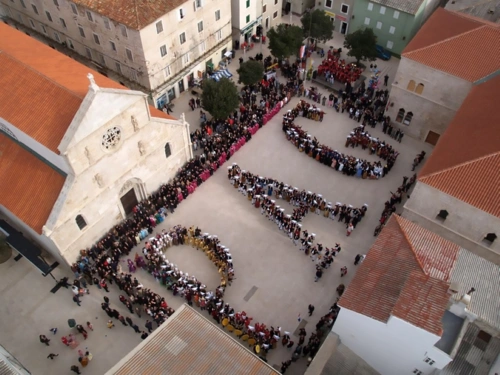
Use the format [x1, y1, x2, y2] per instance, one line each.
[418, 76, 500, 217]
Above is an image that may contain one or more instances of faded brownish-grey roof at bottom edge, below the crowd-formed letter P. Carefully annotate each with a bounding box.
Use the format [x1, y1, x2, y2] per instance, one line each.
[106, 305, 279, 375]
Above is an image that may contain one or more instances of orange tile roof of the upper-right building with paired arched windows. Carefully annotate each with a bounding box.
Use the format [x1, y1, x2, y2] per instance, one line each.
[402, 8, 500, 82]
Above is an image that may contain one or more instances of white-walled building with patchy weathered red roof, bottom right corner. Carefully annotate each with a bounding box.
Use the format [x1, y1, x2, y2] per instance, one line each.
[332, 216, 500, 375]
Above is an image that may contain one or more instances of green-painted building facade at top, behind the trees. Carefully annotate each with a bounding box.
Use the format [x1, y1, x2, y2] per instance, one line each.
[350, 0, 439, 55]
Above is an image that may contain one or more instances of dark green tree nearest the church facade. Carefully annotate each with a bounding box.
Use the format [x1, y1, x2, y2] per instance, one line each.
[201, 78, 240, 120]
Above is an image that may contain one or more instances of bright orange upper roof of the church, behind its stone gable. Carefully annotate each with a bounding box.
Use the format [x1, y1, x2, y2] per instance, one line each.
[0, 23, 174, 153]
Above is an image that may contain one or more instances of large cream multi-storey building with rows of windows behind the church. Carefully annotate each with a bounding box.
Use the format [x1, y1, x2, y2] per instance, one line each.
[0, 0, 232, 108]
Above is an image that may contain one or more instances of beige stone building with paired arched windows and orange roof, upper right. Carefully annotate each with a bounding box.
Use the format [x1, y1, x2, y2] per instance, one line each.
[387, 8, 500, 145]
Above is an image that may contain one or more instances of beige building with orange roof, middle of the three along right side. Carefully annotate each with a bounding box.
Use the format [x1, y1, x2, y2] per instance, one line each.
[403, 75, 500, 265]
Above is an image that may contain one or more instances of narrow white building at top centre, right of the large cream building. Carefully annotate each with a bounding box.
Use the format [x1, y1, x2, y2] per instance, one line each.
[231, 0, 282, 45]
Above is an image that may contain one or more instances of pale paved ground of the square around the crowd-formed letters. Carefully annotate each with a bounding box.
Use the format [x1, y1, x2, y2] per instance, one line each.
[0, 22, 430, 374]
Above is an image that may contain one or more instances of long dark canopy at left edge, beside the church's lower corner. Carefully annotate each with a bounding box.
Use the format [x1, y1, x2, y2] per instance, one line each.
[0, 220, 59, 276]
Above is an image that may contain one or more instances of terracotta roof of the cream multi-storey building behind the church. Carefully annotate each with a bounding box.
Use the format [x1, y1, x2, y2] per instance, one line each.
[73, 0, 192, 30]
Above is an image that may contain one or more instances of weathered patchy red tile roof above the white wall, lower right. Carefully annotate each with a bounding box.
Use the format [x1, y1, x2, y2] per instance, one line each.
[339, 215, 459, 335]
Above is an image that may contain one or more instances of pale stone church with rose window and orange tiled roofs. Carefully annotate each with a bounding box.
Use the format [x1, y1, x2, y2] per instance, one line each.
[0, 24, 192, 263]
